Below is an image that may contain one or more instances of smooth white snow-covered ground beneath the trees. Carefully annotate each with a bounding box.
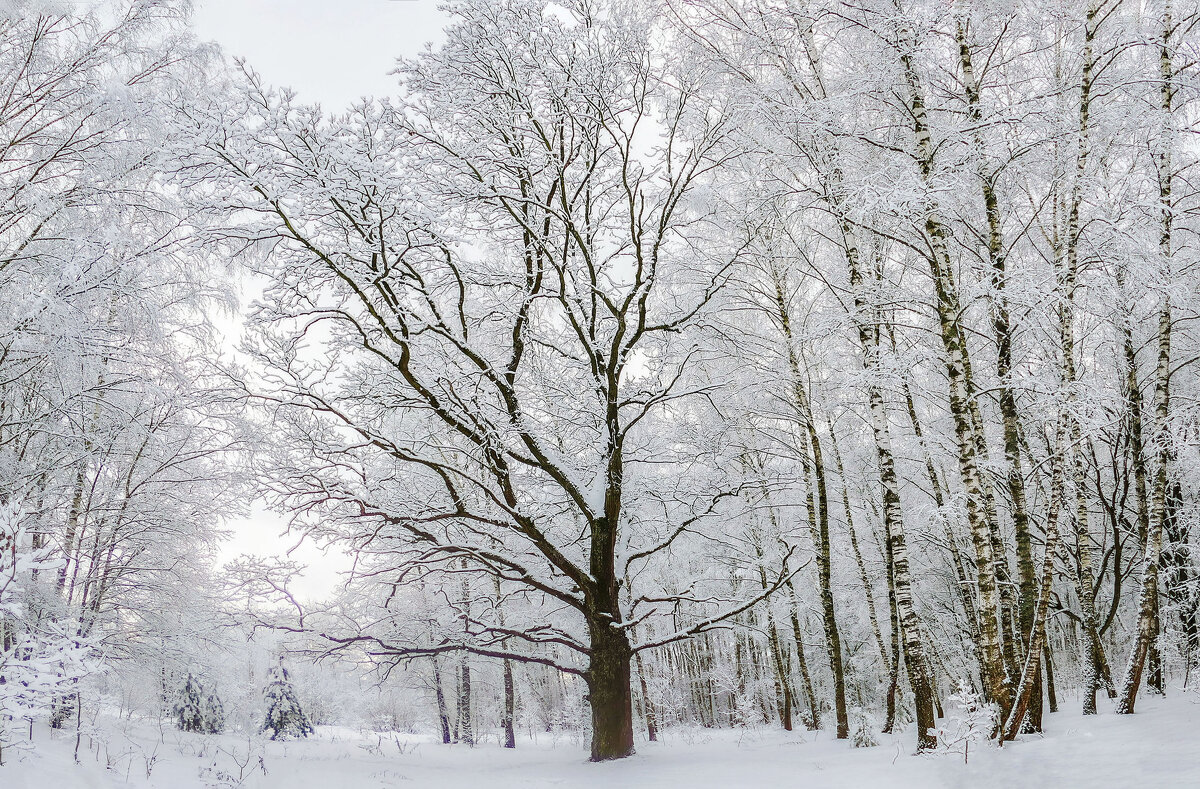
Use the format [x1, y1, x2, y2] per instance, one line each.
[9, 693, 1200, 789]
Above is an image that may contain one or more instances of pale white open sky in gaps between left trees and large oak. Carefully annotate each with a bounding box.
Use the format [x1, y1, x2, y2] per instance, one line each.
[194, 0, 448, 600]
